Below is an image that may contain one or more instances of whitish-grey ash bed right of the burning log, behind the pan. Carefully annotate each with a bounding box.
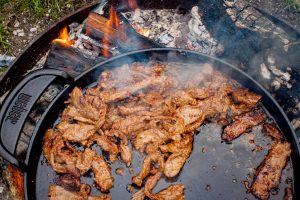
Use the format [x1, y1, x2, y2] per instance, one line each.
[123, 6, 223, 55]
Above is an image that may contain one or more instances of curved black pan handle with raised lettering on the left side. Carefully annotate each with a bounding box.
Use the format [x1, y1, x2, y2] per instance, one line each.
[0, 69, 73, 171]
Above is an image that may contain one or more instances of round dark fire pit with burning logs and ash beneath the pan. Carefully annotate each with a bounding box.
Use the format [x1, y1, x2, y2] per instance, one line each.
[0, 0, 300, 199]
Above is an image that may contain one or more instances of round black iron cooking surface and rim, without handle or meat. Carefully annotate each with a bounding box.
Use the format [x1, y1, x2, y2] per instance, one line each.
[0, 48, 300, 199]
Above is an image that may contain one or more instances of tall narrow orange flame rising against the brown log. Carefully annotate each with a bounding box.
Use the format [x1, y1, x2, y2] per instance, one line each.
[102, 6, 120, 58]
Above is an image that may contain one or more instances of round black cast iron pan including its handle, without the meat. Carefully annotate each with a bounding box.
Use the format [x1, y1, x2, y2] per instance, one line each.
[0, 48, 300, 199]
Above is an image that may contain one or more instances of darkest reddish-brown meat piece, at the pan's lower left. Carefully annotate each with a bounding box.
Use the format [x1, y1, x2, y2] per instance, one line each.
[54, 174, 81, 191]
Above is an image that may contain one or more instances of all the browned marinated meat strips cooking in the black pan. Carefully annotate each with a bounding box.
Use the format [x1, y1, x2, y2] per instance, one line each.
[43, 62, 290, 200]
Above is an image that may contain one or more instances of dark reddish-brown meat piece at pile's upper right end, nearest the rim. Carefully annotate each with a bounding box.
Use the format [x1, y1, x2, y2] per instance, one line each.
[232, 88, 261, 107]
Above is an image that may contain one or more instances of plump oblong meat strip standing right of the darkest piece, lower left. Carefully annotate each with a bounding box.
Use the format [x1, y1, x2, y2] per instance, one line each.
[92, 156, 114, 192]
